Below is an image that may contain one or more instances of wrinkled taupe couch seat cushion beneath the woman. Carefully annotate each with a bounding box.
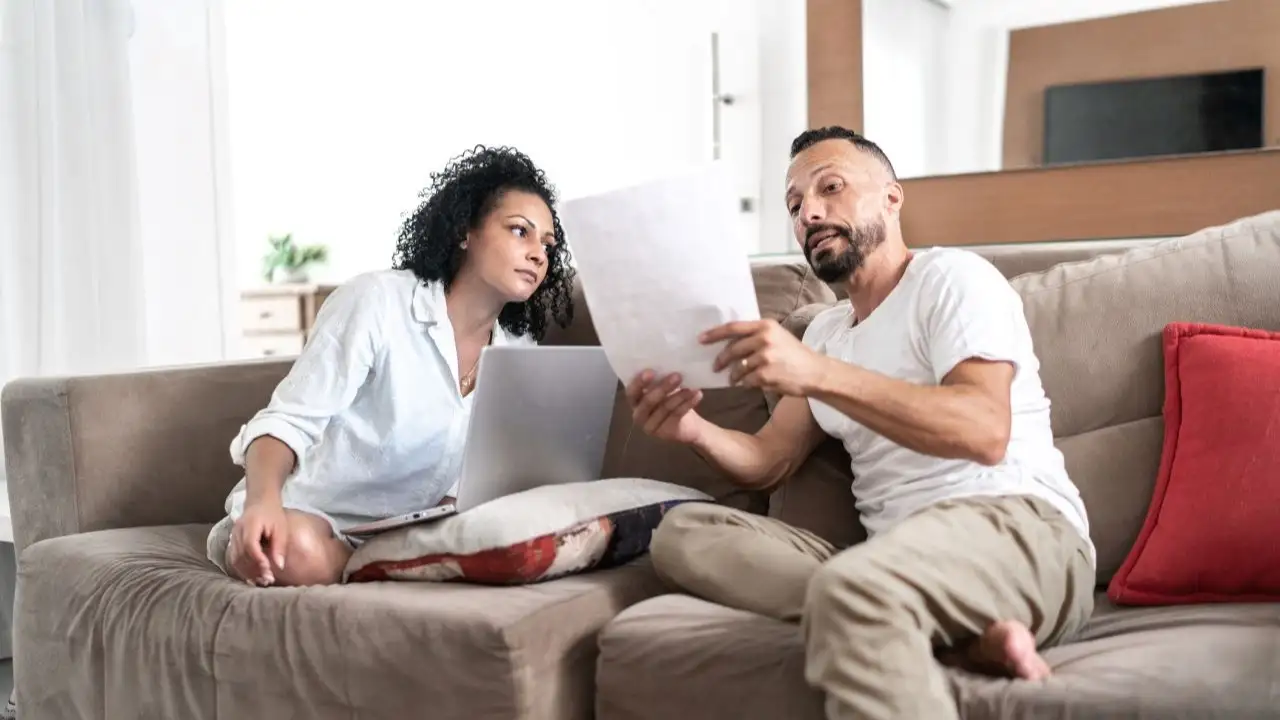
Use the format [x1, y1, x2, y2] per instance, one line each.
[14, 525, 660, 720]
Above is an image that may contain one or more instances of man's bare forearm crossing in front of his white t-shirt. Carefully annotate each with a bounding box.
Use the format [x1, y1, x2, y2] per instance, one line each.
[810, 357, 1007, 465]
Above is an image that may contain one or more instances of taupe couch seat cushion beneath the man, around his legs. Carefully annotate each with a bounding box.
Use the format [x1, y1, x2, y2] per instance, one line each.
[596, 594, 1280, 720]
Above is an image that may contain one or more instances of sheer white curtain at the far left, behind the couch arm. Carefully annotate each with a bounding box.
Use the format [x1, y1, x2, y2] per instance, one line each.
[0, 0, 146, 479]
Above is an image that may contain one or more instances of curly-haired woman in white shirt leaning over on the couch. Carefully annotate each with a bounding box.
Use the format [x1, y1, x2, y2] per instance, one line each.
[209, 147, 572, 587]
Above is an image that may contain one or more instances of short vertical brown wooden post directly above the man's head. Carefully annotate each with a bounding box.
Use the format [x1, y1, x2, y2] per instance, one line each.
[805, 0, 863, 132]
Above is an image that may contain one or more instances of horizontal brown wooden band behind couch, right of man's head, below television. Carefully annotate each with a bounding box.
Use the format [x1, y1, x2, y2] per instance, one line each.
[902, 148, 1280, 247]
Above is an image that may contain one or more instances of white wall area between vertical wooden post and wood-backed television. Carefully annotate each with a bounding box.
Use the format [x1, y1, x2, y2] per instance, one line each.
[863, 0, 1225, 177]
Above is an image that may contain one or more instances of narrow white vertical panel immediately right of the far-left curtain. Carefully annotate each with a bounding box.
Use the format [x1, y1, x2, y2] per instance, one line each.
[129, 0, 236, 365]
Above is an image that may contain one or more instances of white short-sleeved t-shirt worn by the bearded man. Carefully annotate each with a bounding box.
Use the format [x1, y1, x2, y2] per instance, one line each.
[804, 249, 1092, 561]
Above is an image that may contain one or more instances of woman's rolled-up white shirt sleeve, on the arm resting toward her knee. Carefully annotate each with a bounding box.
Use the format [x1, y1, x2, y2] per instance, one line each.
[230, 275, 385, 466]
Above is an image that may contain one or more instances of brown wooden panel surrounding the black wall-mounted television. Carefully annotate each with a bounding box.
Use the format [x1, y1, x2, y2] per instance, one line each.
[1003, 0, 1280, 169]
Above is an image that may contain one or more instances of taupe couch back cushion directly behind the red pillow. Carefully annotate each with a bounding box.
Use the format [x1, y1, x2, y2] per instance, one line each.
[1012, 211, 1280, 584]
